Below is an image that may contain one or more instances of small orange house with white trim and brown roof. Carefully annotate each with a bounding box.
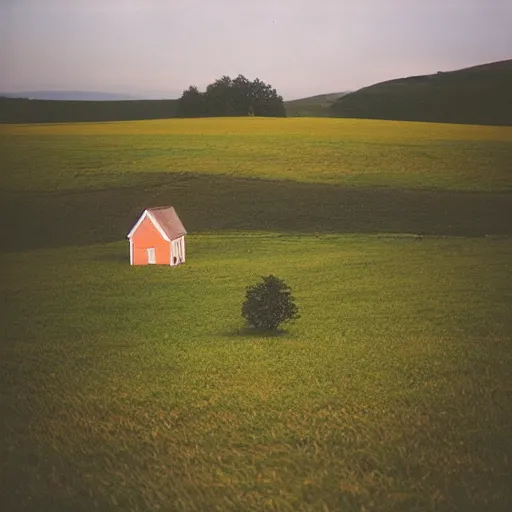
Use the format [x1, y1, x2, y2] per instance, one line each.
[127, 206, 187, 267]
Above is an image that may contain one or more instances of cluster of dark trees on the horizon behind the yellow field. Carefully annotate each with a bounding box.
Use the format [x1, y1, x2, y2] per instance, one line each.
[178, 75, 286, 117]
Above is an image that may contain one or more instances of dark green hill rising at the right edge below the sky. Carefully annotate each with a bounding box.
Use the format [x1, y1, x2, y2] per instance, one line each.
[330, 60, 512, 125]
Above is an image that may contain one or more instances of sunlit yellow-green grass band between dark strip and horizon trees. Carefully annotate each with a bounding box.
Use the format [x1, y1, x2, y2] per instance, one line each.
[0, 118, 512, 191]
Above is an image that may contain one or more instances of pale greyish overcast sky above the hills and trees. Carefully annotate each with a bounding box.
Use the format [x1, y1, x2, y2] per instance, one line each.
[0, 0, 512, 99]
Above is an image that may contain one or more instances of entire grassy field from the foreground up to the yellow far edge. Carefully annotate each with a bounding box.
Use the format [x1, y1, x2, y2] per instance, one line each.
[0, 119, 512, 512]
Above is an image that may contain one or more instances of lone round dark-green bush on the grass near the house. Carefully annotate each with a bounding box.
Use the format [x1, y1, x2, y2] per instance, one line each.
[242, 275, 299, 331]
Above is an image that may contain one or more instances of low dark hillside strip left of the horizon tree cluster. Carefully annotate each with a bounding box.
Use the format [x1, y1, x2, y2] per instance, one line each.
[0, 98, 178, 123]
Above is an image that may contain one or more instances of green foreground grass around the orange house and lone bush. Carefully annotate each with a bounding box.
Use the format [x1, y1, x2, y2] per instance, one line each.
[0, 233, 512, 511]
